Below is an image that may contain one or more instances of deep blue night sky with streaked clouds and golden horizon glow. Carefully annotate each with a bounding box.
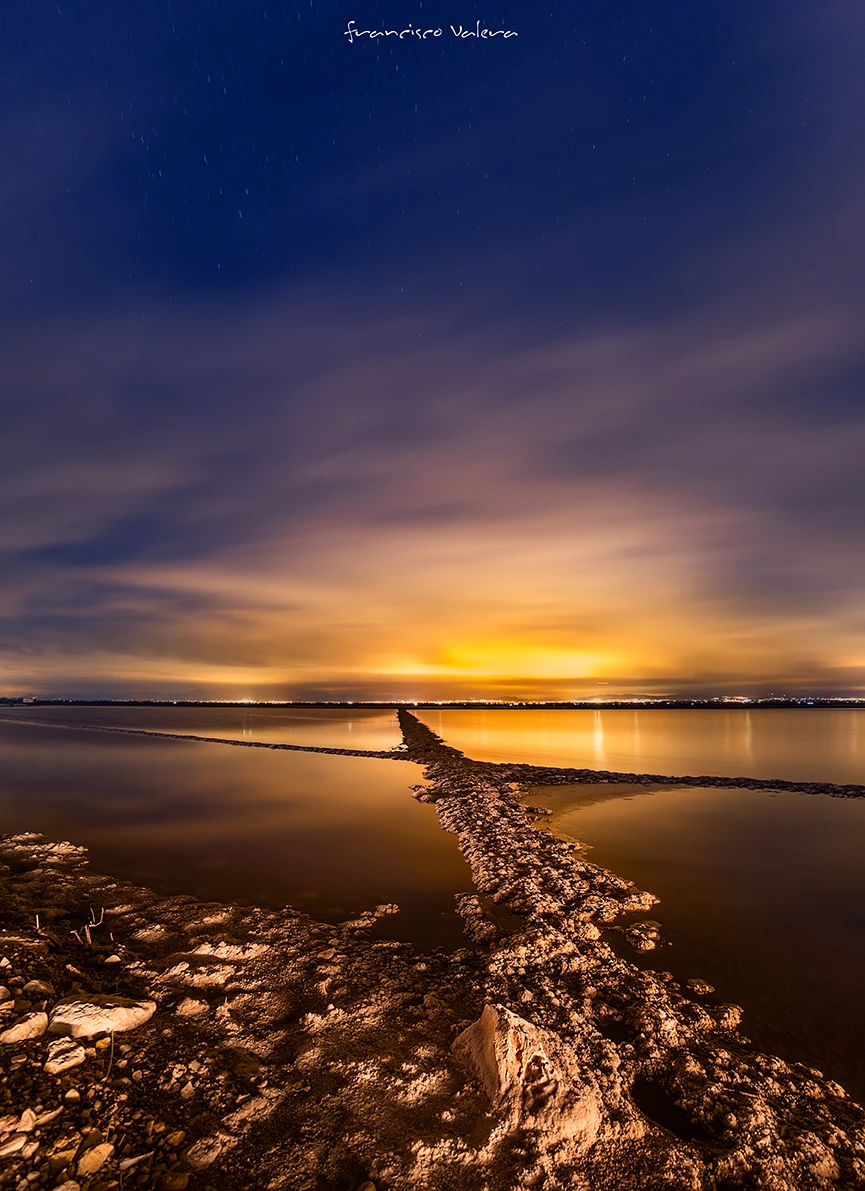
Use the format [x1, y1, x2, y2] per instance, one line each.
[0, 0, 865, 699]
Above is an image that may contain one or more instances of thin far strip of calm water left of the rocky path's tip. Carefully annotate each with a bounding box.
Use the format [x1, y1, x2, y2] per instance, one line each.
[0, 706, 403, 752]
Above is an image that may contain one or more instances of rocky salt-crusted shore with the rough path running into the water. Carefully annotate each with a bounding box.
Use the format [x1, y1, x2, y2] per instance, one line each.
[0, 712, 865, 1191]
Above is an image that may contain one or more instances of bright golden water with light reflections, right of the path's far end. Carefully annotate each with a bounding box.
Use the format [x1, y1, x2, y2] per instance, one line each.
[417, 707, 865, 785]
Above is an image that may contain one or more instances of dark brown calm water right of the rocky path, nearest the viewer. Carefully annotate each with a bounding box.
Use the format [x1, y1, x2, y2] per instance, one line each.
[538, 787, 865, 1102]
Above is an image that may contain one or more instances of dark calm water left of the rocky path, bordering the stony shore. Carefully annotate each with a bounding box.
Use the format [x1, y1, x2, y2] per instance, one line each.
[0, 724, 472, 946]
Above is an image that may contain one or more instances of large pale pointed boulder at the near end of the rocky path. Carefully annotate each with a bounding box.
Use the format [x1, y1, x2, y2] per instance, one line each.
[453, 1005, 602, 1149]
